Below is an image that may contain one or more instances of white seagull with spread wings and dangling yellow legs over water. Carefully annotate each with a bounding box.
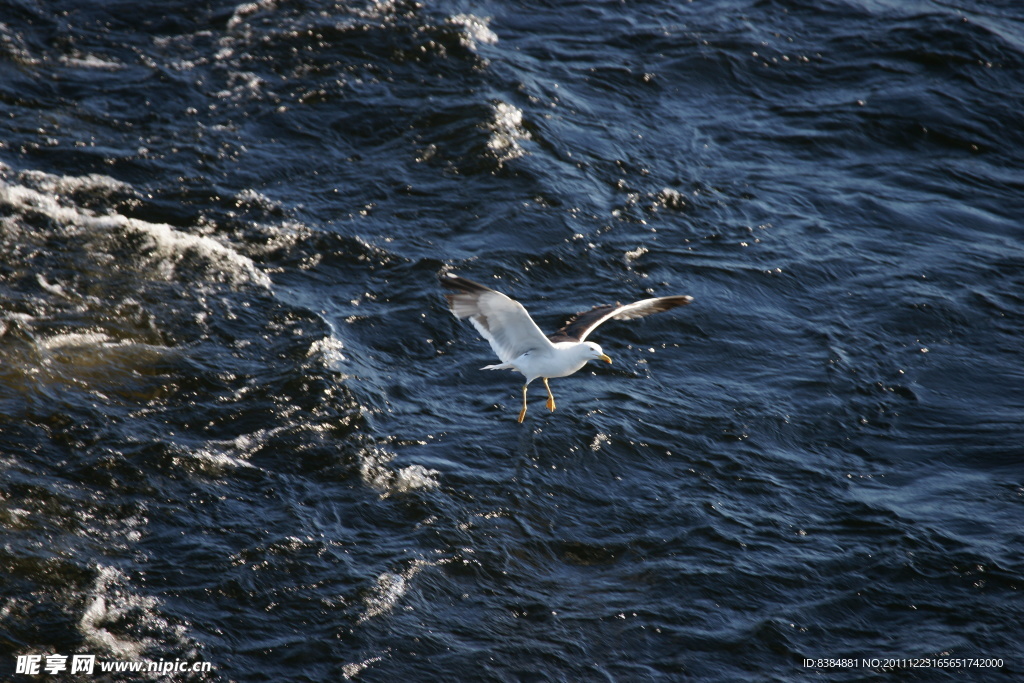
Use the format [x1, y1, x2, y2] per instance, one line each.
[438, 272, 693, 423]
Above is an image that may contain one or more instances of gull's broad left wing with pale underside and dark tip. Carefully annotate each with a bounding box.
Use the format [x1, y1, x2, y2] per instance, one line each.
[439, 272, 551, 362]
